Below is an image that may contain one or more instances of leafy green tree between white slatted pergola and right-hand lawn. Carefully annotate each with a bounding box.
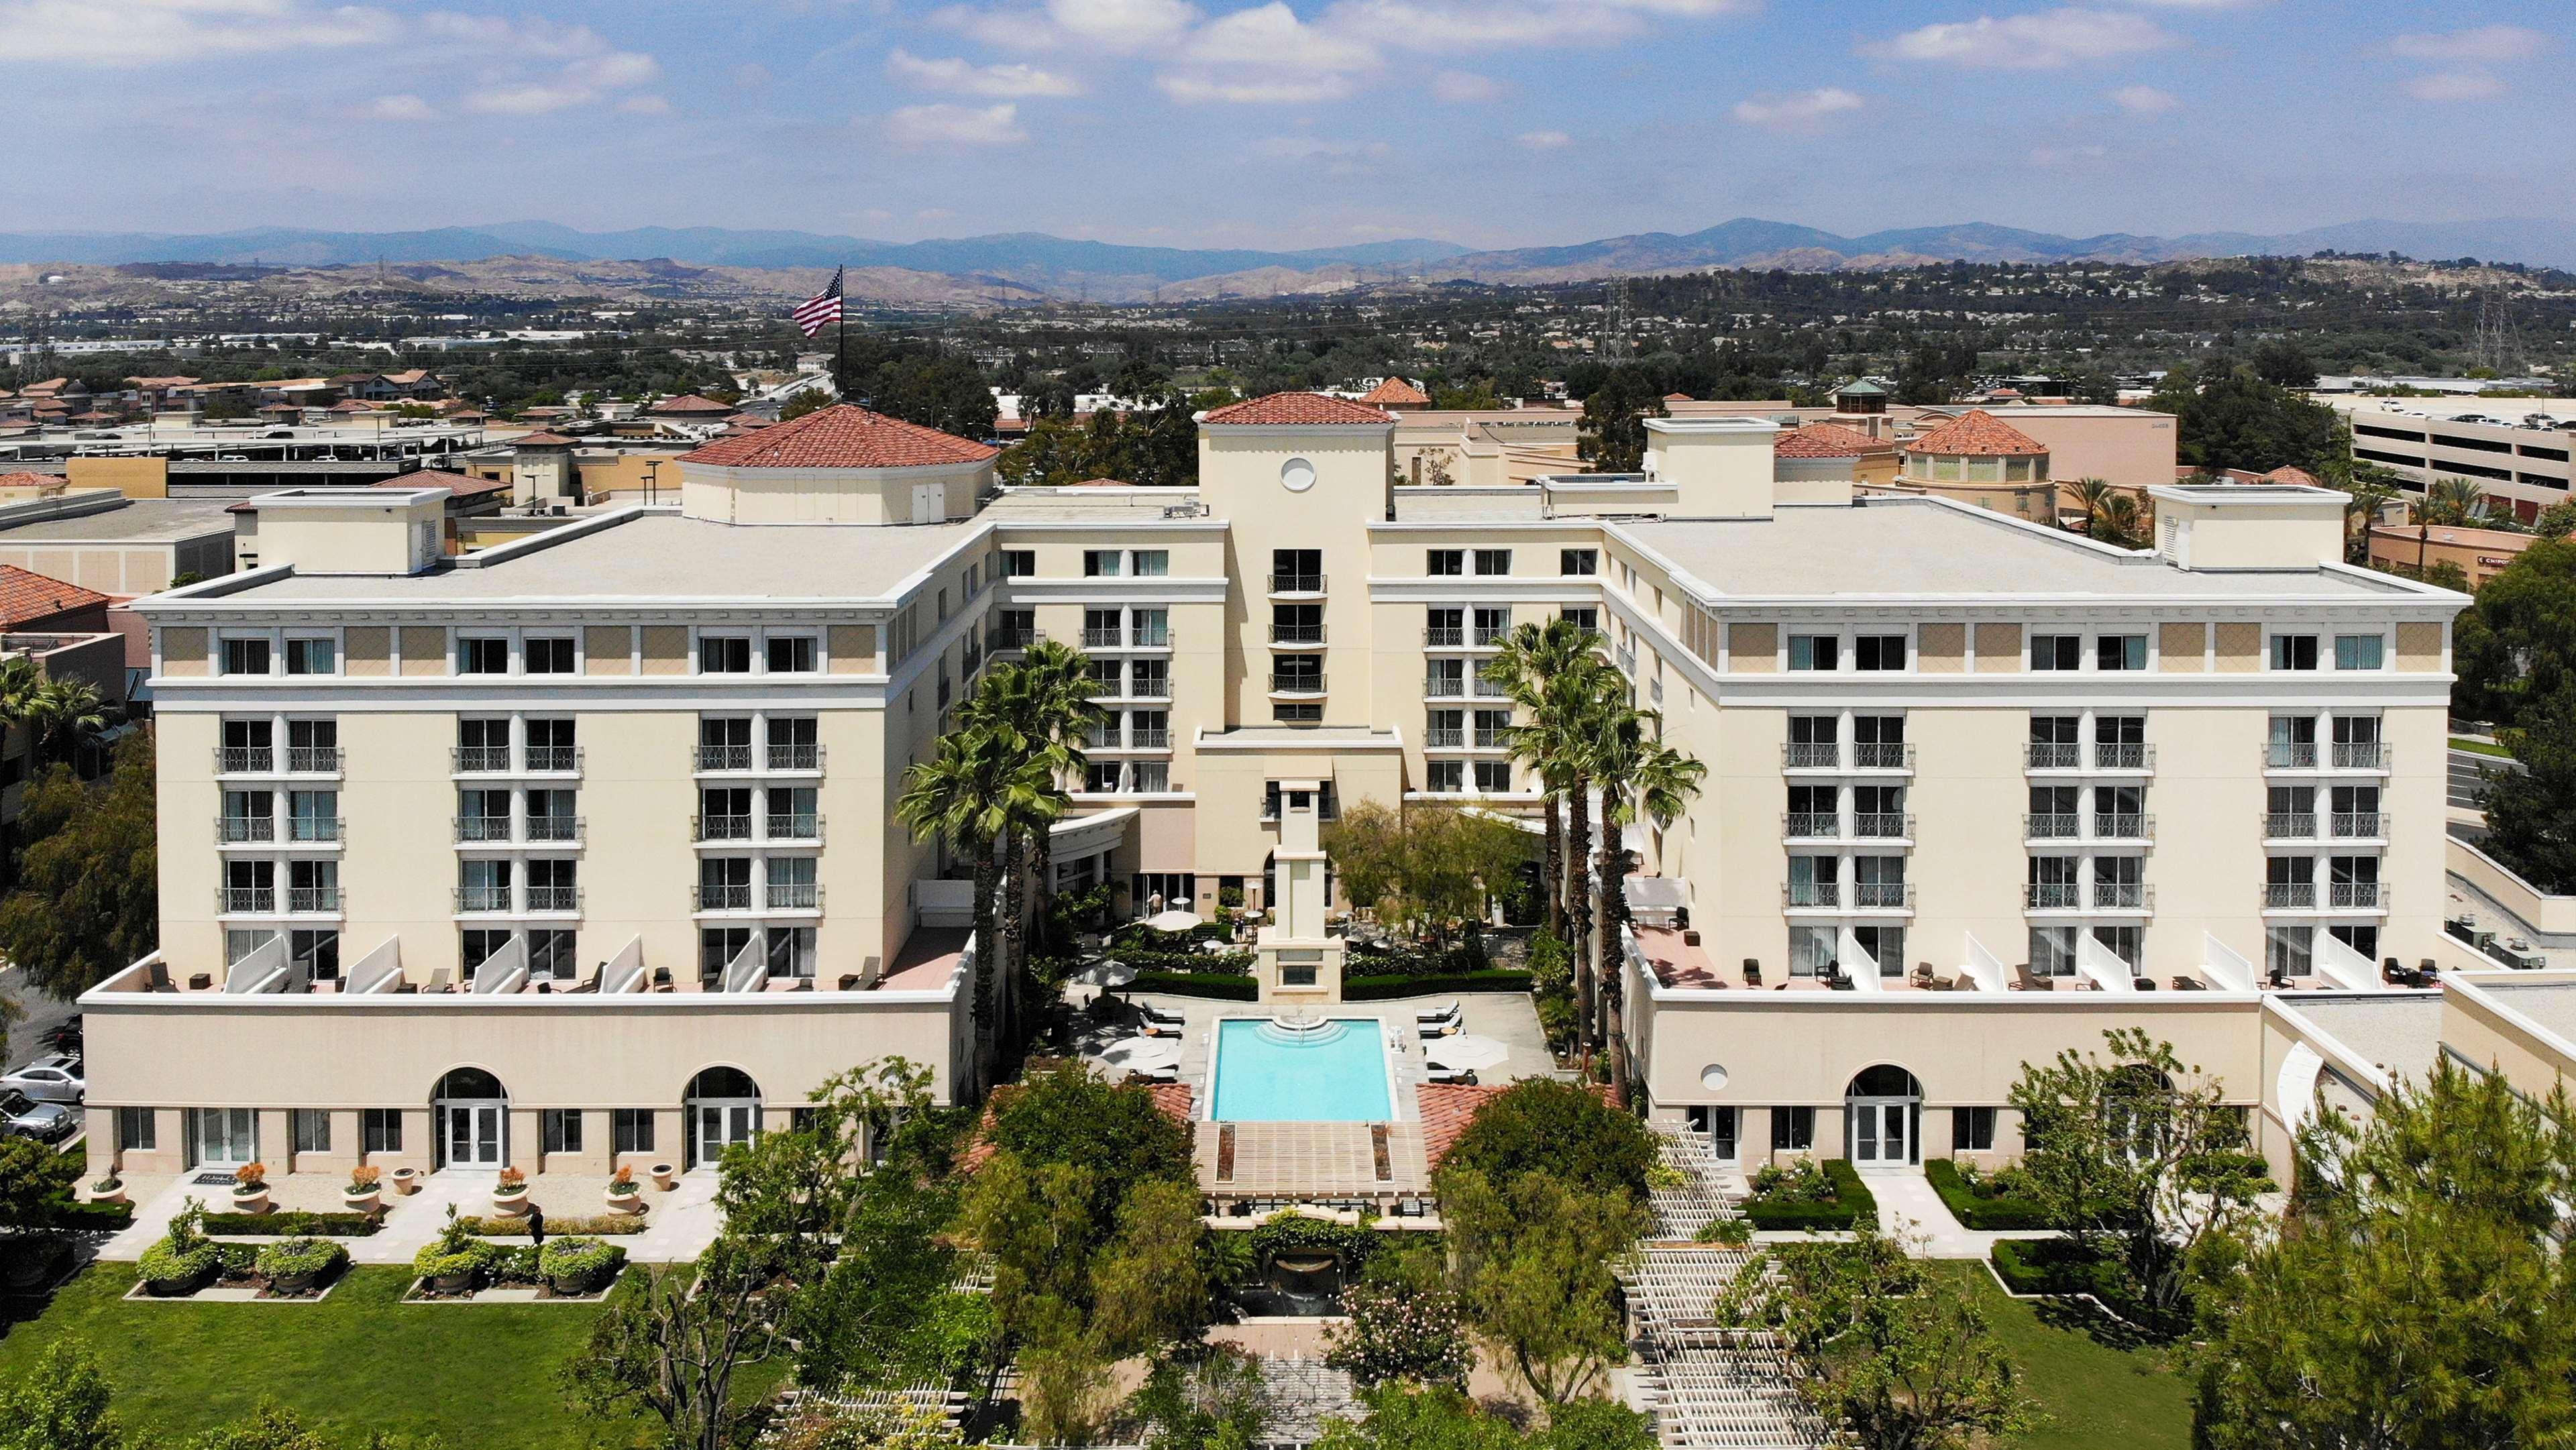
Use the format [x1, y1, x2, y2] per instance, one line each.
[1713, 1223, 2040, 1450]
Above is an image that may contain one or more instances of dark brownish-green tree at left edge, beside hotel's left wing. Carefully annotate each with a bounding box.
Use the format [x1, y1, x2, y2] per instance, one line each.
[0, 732, 160, 997]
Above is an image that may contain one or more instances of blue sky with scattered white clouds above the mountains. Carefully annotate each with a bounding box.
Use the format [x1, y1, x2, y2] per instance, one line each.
[0, 0, 2576, 247]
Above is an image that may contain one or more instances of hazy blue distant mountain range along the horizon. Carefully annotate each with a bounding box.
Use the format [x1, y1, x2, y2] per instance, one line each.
[0, 217, 2576, 301]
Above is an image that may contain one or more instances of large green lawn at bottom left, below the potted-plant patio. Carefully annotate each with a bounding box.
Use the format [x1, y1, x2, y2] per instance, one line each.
[0, 1265, 647, 1450]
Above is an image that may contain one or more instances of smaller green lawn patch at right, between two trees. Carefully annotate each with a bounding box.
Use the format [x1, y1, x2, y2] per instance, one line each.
[1955, 1265, 2192, 1450]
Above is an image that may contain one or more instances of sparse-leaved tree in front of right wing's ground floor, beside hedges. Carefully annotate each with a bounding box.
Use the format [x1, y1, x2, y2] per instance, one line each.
[2009, 1027, 2272, 1316]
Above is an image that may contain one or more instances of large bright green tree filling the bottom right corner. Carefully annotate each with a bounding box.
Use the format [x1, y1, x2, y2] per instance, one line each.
[2195, 1061, 2576, 1450]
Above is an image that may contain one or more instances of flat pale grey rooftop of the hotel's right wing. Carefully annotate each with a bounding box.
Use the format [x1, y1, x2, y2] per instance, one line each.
[1610, 490, 2408, 600]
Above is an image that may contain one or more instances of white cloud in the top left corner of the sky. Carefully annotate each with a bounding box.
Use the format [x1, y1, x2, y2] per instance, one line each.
[0, 0, 402, 67]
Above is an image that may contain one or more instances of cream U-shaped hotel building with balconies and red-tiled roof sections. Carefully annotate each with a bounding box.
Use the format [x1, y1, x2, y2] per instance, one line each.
[83, 394, 2475, 1172]
